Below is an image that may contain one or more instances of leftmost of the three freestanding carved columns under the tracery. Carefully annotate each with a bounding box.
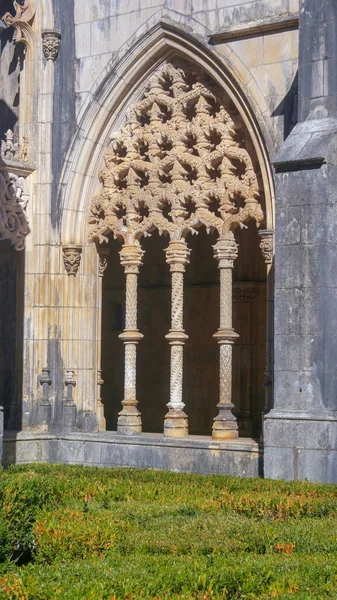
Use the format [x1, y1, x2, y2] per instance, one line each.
[117, 244, 144, 434]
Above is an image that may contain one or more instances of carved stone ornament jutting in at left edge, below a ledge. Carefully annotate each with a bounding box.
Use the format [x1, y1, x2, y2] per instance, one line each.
[0, 165, 29, 250]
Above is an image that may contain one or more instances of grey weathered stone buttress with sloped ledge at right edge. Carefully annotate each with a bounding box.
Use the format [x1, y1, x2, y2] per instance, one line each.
[265, 0, 337, 482]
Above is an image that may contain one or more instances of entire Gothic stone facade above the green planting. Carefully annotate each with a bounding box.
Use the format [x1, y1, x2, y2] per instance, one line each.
[0, 0, 337, 482]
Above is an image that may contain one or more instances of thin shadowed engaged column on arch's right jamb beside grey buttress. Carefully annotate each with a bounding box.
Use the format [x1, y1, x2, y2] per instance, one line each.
[259, 229, 274, 413]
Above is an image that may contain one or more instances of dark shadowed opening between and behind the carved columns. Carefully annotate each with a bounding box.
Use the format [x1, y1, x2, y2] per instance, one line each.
[102, 224, 266, 438]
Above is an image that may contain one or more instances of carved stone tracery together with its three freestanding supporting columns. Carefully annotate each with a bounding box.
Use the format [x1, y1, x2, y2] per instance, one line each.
[89, 58, 264, 439]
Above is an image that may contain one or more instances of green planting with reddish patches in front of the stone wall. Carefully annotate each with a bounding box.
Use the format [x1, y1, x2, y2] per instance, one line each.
[0, 465, 337, 600]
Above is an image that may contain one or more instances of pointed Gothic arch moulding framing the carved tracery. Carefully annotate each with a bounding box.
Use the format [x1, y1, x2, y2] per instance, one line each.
[59, 21, 274, 246]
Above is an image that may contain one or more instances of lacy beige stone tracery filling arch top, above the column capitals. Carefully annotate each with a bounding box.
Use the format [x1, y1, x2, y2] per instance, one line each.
[90, 59, 264, 245]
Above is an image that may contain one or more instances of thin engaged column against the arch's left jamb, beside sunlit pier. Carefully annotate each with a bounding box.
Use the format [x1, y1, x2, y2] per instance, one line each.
[96, 248, 109, 431]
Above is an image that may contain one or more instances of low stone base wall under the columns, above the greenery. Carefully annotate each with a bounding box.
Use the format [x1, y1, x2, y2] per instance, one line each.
[3, 432, 262, 477]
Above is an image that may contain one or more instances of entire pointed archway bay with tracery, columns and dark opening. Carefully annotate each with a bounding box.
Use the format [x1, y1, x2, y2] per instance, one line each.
[90, 57, 265, 439]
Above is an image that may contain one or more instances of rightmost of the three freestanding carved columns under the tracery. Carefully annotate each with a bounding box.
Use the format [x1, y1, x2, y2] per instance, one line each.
[212, 232, 238, 440]
